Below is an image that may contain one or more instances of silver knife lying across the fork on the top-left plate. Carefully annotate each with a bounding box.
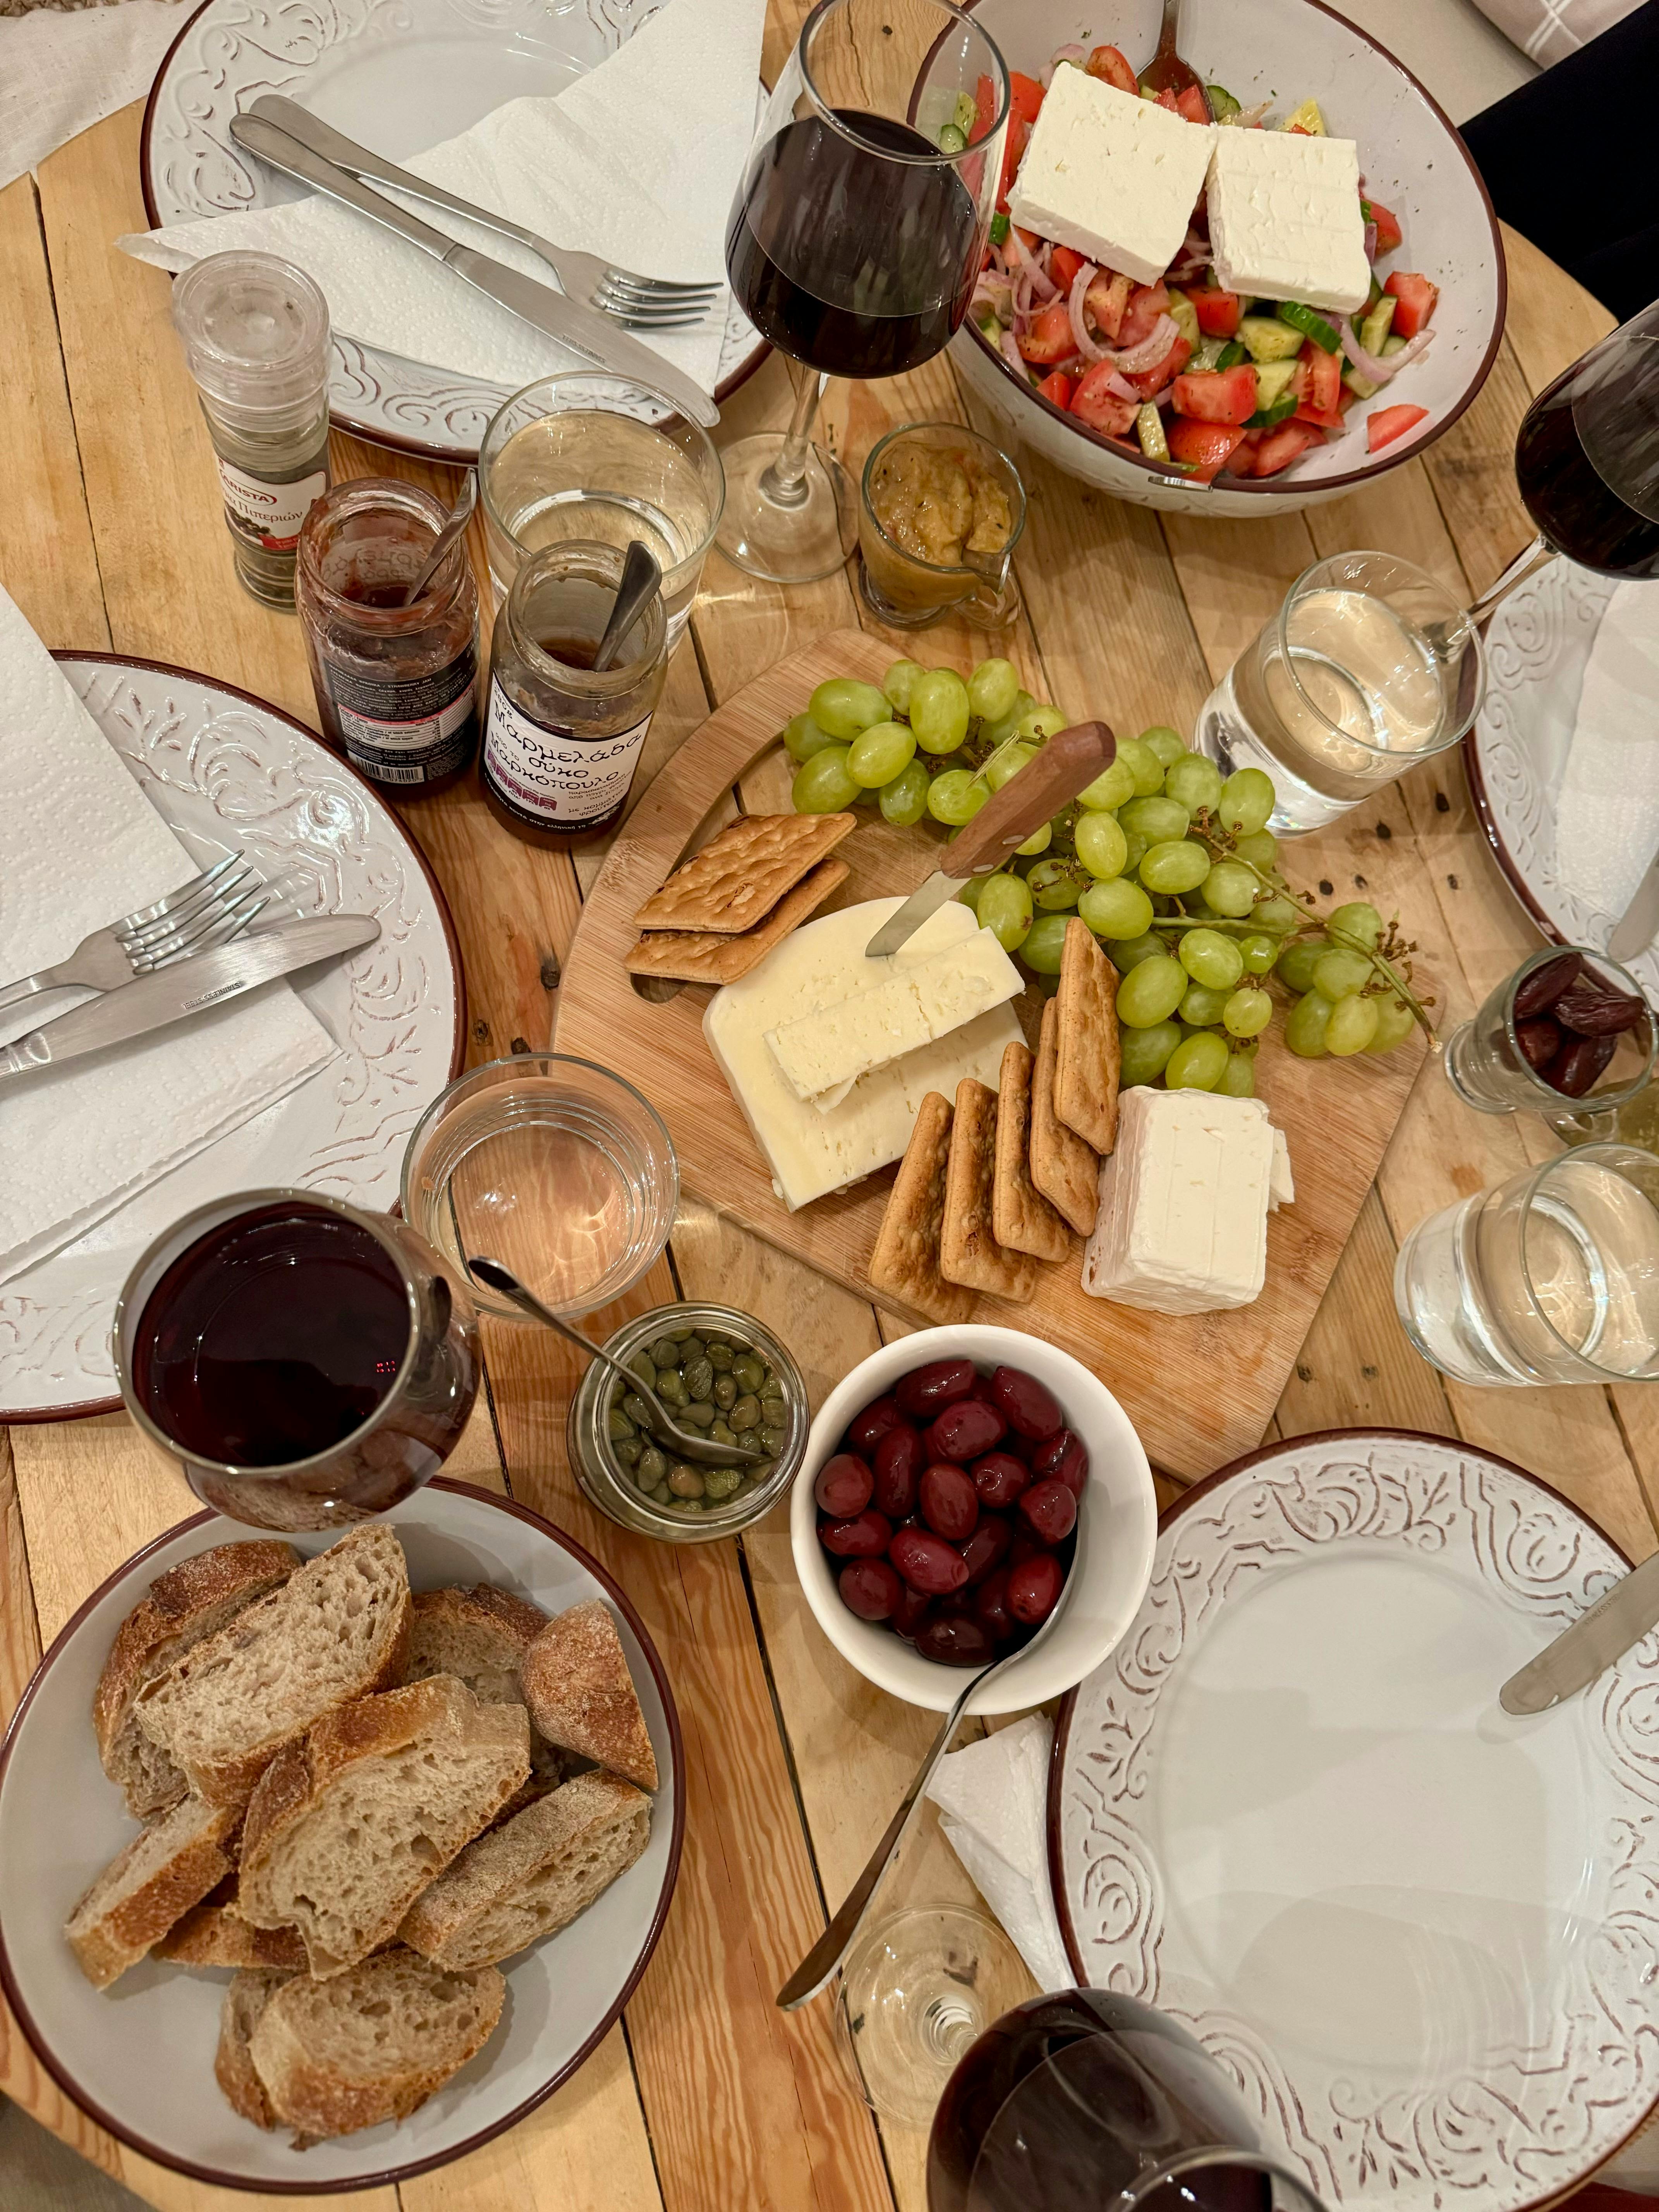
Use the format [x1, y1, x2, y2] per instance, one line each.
[230, 115, 721, 429]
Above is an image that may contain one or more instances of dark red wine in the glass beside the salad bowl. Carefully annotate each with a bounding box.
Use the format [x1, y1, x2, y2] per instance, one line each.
[726, 108, 978, 376]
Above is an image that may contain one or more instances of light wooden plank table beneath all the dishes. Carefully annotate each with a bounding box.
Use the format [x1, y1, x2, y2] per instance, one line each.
[0, 52, 1659, 2212]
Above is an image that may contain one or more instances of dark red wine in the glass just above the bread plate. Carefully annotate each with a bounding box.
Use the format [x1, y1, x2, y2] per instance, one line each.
[133, 1201, 409, 1467]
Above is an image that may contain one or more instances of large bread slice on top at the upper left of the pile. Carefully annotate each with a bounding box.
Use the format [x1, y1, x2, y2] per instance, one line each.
[133, 1522, 409, 1805]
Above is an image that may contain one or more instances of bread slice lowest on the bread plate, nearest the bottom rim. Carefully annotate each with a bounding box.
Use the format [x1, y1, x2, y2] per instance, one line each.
[246, 1951, 507, 2141]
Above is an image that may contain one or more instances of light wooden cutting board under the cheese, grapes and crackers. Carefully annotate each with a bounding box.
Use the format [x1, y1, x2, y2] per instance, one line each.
[555, 630, 1422, 1475]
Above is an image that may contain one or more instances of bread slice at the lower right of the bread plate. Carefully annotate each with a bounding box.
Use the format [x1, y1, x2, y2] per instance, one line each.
[398, 1770, 650, 1969]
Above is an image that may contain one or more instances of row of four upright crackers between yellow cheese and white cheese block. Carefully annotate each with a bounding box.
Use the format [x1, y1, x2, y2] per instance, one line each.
[869, 916, 1119, 1323]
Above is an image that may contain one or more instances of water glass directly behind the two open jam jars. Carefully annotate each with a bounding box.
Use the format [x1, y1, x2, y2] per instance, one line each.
[478, 369, 726, 653]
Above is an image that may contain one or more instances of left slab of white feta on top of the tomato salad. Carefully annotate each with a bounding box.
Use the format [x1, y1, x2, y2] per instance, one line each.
[1009, 69, 1212, 283]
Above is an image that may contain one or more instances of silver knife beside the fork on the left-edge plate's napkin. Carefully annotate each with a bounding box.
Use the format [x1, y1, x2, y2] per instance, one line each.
[0, 914, 380, 1082]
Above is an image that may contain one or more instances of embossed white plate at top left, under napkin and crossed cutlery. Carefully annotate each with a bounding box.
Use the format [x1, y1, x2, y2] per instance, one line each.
[139, 0, 768, 462]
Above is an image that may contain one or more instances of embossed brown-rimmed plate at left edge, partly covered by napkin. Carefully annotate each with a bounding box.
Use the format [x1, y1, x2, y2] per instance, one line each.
[0, 653, 467, 1420]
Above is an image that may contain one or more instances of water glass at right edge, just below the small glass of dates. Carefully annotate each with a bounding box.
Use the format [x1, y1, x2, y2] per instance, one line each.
[1394, 1144, 1659, 1385]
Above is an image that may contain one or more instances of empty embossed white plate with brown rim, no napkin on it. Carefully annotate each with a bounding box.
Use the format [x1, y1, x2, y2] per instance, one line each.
[1048, 1431, 1659, 2212]
